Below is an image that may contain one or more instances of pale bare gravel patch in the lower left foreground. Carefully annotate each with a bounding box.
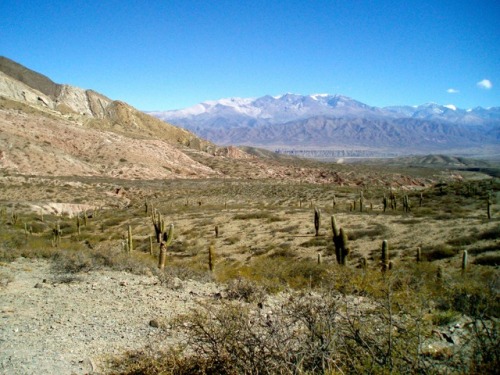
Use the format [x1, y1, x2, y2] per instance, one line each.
[0, 258, 217, 375]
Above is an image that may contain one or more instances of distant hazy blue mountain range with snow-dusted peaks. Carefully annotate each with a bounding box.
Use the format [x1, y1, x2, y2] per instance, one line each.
[149, 94, 500, 158]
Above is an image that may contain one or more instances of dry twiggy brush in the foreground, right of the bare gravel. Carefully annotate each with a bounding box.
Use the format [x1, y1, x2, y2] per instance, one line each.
[112, 266, 500, 374]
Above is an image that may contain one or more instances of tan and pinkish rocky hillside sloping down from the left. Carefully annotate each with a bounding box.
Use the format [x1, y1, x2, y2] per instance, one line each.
[0, 57, 250, 179]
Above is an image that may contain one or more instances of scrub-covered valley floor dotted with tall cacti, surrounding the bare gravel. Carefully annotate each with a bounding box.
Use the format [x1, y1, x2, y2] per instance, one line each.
[0, 167, 500, 374]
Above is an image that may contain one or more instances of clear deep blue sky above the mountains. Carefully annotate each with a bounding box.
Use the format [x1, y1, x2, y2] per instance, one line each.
[0, 0, 500, 110]
